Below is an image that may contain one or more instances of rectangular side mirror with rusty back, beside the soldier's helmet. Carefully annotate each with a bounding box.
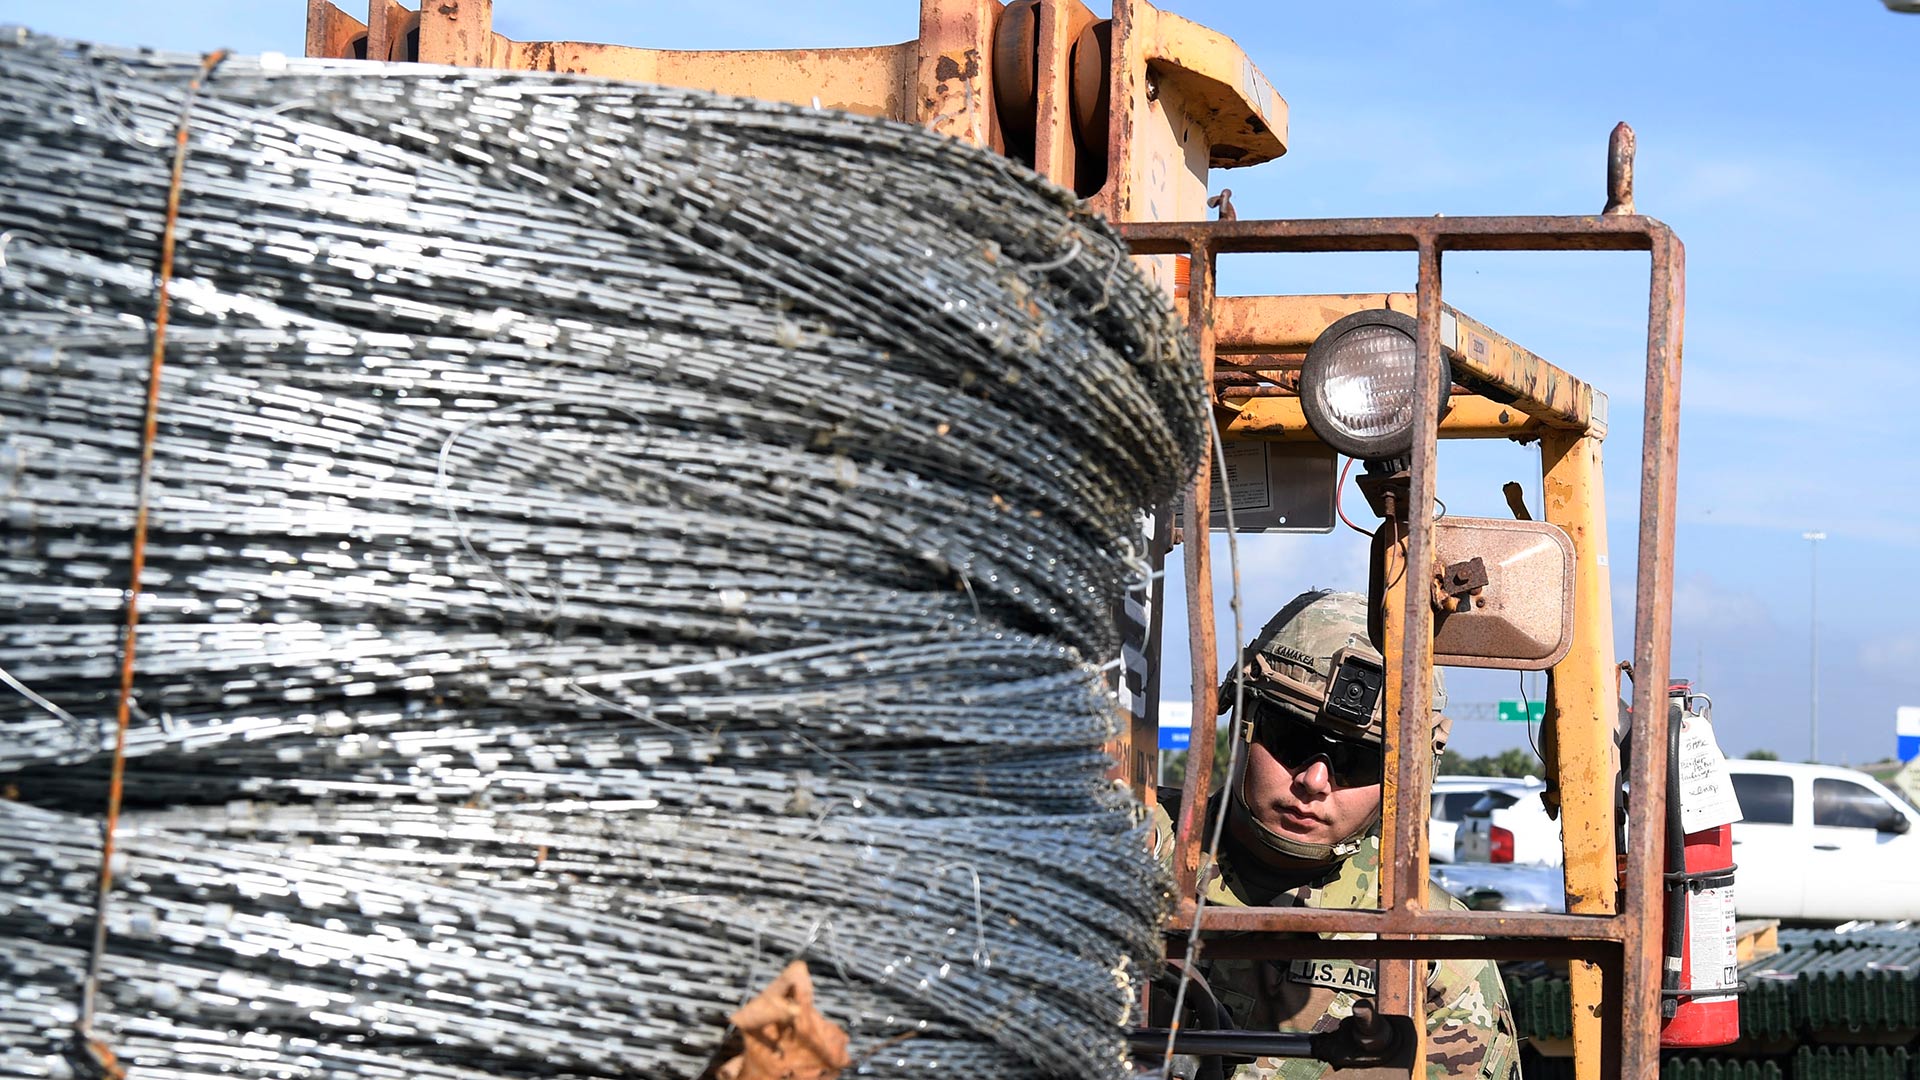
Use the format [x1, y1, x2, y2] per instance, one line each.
[1367, 517, 1574, 671]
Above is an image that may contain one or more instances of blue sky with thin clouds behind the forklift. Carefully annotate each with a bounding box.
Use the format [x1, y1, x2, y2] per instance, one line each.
[15, 0, 1920, 763]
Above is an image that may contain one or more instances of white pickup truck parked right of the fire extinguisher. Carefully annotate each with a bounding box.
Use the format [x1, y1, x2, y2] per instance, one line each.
[1726, 761, 1920, 922]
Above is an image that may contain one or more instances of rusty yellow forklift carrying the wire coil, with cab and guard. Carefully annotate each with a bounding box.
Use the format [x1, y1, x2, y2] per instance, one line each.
[295, 0, 1686, 1080]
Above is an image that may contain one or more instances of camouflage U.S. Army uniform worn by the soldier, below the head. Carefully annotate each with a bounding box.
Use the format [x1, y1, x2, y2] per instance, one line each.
[1154, 807, 1521, 1080]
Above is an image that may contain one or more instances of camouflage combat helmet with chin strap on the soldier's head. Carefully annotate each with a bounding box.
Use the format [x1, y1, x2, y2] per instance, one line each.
[1219, 590, 1450, 863]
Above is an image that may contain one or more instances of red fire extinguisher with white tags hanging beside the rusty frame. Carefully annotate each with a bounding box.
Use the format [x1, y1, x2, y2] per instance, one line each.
[1661, 682, 1740, 1047]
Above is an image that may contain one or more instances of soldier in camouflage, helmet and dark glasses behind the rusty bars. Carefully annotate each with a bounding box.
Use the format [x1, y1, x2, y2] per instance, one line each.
[1156, 592, 1519, 1080]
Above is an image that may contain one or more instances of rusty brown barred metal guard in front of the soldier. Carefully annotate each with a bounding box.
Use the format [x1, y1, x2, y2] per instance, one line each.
[1121, 210, 1686, 1076]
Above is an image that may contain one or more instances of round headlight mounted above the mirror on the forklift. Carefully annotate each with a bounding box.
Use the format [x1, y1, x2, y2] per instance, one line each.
[1300, 309, 1453, 461]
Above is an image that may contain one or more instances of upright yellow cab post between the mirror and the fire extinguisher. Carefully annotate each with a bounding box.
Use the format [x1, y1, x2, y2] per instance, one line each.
[1540, 429, 1620, 1080]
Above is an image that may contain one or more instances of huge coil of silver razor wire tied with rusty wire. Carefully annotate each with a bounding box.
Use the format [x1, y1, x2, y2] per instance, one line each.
[0, 33, 1206, 1078]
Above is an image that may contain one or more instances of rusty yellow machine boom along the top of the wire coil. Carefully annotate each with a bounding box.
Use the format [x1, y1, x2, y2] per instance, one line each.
[307, 0, 1286, 226]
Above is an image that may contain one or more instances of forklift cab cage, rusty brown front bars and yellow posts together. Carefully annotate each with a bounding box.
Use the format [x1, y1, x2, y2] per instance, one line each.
[1121, 187, 1686, 1076]
